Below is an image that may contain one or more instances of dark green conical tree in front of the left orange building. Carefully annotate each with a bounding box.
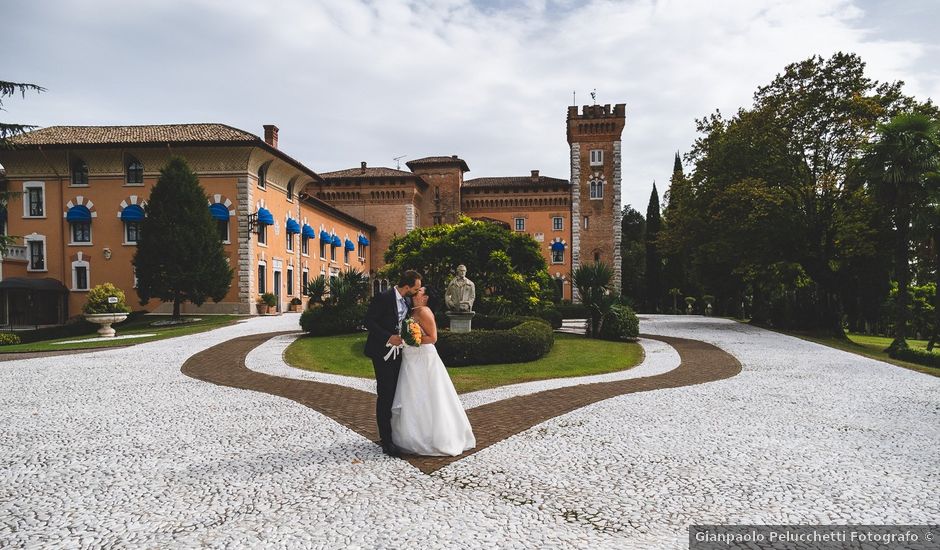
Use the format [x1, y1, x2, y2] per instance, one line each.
[134, 157, 233, 319]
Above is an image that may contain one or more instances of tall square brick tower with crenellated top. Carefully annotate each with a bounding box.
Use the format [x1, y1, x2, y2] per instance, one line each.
[568, 103, 626, 299]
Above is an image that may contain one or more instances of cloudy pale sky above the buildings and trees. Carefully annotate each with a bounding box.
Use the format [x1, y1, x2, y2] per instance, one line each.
[0, 0, 940, 213]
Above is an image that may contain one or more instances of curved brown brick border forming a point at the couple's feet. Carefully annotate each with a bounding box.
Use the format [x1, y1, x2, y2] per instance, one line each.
[181, 331, 741, 474]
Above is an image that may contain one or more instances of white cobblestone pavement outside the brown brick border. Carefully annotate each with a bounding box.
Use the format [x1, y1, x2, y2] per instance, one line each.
[0, 315, 940, 548]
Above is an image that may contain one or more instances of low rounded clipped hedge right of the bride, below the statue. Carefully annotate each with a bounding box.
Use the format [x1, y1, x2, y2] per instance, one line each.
[437, 317, 555, 367]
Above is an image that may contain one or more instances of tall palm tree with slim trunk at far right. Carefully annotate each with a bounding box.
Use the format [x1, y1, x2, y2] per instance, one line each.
[868, 113, 940, 352]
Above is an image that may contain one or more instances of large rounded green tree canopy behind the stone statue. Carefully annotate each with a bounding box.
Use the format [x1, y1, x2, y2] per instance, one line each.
[380, 217, 553, 313]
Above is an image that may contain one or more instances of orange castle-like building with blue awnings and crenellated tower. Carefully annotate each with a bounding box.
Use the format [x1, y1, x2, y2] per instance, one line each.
[0, 104, 625, 327]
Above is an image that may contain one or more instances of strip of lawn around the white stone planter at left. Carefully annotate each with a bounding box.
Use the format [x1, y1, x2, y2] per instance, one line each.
[0, 315, 245, 354]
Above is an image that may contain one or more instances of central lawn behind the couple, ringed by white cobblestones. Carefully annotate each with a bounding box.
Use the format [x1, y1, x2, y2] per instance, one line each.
[284, 333, 643, 393]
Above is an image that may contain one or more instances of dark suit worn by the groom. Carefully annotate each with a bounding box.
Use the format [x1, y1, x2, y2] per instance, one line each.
[365, 288, 408, 444]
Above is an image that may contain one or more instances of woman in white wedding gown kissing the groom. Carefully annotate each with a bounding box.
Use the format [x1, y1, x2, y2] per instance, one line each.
[392, 288, 476, 456]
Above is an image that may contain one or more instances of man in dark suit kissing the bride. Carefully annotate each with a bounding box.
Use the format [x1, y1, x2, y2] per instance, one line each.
[366, 270, 421, 457]
